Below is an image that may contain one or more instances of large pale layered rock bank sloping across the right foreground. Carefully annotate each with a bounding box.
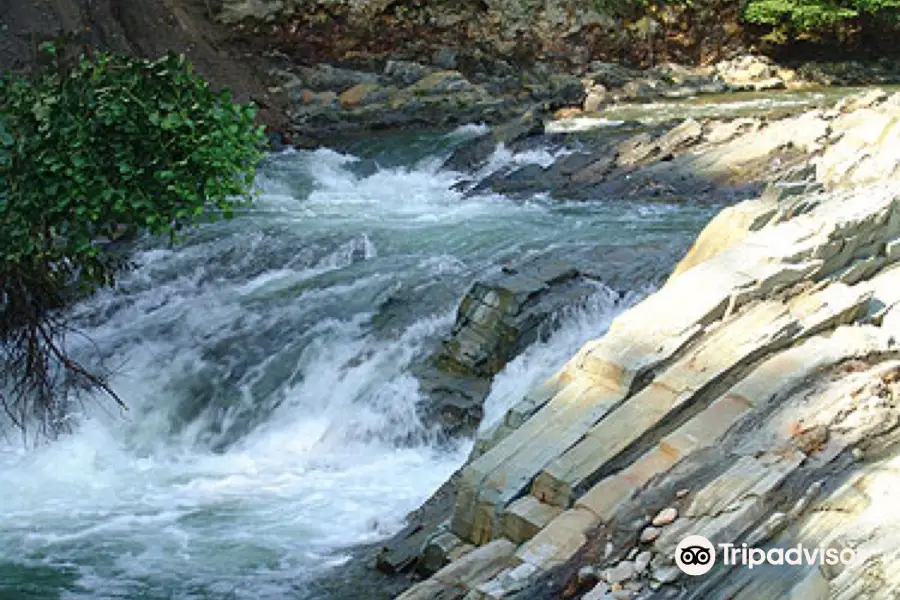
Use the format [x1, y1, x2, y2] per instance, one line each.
[389, 92, 900, 600]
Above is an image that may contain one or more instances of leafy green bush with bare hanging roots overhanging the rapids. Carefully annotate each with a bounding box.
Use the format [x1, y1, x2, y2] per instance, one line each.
[0, 44, 265, 436]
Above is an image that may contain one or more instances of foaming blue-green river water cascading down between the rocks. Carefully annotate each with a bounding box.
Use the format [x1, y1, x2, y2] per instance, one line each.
[0, 128, 712, 600]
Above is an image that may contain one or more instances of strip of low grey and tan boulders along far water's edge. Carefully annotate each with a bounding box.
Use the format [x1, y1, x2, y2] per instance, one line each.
[270, 53, 900, 146]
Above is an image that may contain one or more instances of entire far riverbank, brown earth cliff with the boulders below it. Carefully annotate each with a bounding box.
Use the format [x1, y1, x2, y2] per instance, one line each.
[0, 0, 900, 147]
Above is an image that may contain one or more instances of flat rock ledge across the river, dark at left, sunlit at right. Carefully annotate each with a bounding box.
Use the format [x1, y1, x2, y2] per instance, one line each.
[448, 105, 835, 202]
